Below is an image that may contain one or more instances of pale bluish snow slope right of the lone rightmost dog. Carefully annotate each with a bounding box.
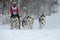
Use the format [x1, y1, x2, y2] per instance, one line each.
[46, 6, 60, 29]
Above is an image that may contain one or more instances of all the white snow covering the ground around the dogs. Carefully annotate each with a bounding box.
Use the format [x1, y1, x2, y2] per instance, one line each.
[0, 9, 60, 40]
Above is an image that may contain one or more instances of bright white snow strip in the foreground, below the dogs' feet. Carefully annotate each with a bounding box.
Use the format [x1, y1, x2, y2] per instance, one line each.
[0, 29, 60, 40]
